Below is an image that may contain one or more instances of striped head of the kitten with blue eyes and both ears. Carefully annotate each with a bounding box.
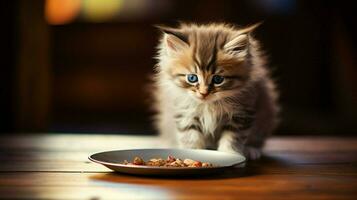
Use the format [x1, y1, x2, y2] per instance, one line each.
[158, 24, 258, 102]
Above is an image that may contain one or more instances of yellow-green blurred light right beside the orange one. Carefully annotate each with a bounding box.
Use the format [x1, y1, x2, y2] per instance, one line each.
[82, 0, 123, 22]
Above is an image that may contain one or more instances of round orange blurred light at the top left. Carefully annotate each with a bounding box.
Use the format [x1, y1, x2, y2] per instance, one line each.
[45, 0, 82, 25]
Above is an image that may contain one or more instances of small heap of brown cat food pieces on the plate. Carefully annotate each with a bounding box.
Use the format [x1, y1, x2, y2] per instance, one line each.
[122, 156, 213, 167]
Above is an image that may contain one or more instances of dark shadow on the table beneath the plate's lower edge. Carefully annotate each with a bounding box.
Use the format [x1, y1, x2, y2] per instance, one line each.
[90, 156, 287, 183]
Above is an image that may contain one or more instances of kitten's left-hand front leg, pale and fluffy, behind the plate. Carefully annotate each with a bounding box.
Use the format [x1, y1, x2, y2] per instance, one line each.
[176, 129, 206, 149]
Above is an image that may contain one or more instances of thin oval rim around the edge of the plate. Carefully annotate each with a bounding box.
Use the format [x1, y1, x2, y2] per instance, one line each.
[88, 148, 247, 170]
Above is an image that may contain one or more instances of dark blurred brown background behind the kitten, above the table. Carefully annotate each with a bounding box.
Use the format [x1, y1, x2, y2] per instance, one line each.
[0, 0, 357, 136]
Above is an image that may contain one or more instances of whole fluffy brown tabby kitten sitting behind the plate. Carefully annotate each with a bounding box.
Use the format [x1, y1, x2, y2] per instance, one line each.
[154, 24, 279, 159]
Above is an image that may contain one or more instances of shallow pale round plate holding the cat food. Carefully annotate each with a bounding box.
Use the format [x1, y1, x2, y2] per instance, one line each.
[89, 149, 246, 175]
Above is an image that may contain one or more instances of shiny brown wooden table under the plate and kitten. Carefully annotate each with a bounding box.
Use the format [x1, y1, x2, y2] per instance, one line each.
[0, 134, 357, 200]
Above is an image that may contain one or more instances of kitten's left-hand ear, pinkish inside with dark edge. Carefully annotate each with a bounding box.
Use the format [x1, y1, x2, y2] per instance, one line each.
[156, 25, 189, 53]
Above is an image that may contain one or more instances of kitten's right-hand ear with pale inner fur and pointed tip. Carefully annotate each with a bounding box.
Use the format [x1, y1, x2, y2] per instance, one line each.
[223, 22, 261, 57]
